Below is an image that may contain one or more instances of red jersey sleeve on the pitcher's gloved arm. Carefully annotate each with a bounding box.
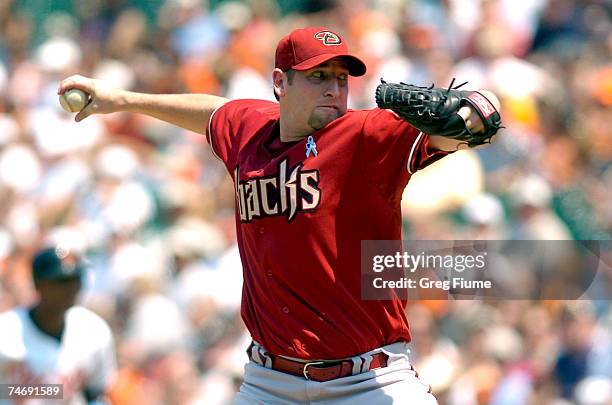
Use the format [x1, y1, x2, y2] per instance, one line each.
[363, 108, 451, 196]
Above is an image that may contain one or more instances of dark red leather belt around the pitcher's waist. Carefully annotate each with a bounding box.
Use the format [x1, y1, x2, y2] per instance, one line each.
[249, 342, 389, 382]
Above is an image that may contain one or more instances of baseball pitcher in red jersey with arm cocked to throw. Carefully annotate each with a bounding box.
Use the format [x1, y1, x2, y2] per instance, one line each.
[58, 27, 500, 404]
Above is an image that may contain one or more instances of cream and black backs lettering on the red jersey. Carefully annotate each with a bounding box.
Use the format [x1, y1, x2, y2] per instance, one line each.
[234, 158, 321, 222]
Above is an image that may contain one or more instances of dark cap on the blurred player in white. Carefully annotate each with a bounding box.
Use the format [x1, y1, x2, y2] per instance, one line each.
[32, 247, 85, 280]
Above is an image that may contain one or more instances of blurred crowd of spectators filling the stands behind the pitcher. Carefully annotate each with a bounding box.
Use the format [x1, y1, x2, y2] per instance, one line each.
[0, 0, 612, 405]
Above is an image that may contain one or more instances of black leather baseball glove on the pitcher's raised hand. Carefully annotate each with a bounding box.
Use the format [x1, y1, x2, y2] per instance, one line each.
[376, 79, 501, 147]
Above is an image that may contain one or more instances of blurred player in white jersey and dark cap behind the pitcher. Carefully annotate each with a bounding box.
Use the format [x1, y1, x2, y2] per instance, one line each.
[0, 246, 116, 405]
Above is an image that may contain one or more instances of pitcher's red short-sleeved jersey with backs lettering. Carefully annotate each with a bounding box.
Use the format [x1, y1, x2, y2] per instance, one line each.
[208, 100, 447, 359]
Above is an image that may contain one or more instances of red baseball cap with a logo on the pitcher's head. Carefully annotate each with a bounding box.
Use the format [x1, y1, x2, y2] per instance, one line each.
[274, 27, 366, 76]
